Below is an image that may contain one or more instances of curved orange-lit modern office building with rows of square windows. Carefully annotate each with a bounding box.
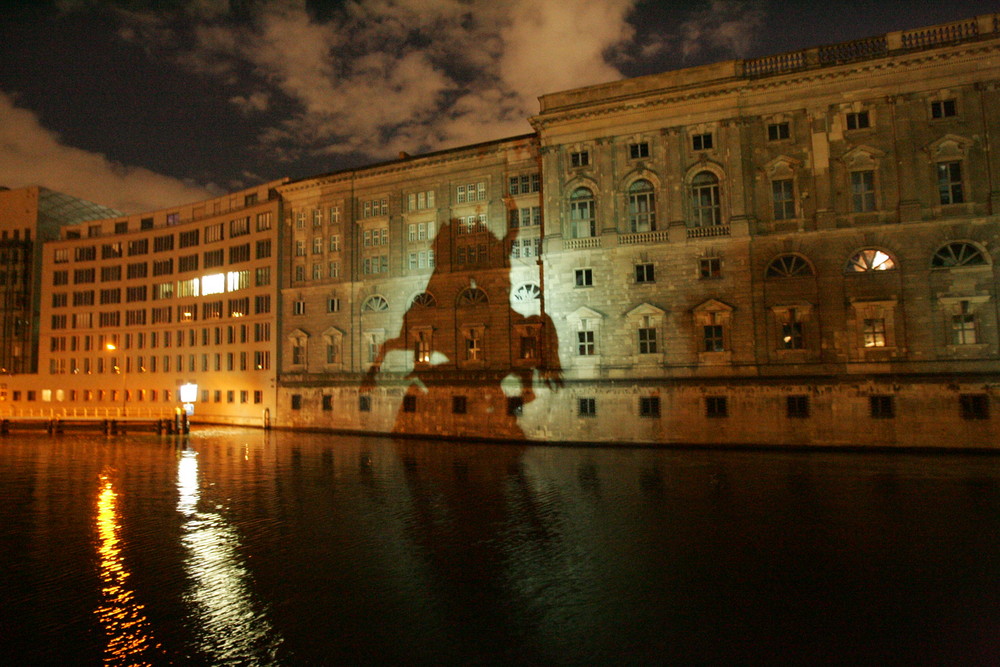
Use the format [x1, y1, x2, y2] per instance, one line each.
[6, 181, 281, 424]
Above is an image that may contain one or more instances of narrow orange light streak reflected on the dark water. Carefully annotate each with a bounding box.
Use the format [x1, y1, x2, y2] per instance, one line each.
[94, 473, 160, 665]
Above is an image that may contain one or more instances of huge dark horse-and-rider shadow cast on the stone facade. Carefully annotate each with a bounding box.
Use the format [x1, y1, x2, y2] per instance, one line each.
[362, 219, 562, 440]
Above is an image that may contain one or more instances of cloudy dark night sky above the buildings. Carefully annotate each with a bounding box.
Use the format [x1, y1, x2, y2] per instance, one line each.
[0, 0, 1000, 212]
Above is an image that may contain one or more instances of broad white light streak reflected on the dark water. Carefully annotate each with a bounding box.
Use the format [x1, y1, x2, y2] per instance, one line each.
[177, 449, 281, 664]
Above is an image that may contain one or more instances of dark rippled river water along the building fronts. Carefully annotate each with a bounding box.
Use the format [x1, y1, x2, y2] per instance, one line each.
[0, 429, 1000, 665]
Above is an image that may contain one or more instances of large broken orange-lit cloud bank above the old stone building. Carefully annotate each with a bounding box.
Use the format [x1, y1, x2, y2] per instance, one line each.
[86, 0, 763, 167]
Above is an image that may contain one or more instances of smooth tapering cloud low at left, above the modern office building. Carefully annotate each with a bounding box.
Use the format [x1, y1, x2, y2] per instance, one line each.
[0, 92, 221, 213]
